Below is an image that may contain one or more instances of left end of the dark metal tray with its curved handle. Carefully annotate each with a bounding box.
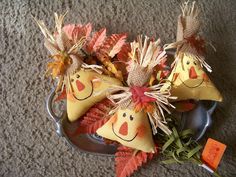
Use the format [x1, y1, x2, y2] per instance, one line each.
[46, 90, 117, 156]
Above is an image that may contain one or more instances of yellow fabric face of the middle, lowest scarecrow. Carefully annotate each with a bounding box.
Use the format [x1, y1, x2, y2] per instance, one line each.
[97, 109, 155, 152]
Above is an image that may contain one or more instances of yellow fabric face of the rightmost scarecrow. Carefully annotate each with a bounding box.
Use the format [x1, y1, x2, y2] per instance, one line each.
[162, 54, 222, 101]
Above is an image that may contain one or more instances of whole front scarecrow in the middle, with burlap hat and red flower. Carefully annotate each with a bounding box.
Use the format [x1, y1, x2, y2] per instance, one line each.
[97, 36, 175, 153]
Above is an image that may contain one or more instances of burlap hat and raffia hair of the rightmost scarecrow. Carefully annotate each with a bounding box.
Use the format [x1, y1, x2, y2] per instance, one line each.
[164, 1, 212, 72]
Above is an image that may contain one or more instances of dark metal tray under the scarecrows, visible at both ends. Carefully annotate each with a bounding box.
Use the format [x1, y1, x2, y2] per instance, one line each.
[46, 90, 217, 156]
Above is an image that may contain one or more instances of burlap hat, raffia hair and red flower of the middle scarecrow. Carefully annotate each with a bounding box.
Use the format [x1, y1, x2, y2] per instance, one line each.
[101, 36, 175, 134]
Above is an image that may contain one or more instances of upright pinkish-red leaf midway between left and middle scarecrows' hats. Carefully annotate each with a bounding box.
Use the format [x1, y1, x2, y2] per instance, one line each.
[86, 28, 106, 53]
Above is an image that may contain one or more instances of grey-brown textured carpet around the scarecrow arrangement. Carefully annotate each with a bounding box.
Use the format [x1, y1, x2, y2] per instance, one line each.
[0, 0, 236, 177]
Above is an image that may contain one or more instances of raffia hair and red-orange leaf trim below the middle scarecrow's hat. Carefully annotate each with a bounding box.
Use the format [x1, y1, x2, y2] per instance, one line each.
[107, 84, 176, 134]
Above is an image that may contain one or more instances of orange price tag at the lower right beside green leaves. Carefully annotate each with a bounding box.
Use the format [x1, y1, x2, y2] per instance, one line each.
[202, 138, 226, 170]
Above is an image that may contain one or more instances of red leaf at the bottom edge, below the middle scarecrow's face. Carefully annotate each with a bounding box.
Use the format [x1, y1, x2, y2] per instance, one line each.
[115, 146, 158, 177]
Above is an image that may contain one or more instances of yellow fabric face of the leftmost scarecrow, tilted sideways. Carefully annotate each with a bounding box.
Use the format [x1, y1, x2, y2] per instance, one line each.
[67, 69, 122, 121]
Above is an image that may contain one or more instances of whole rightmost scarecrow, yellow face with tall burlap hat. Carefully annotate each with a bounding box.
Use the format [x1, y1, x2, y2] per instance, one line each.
[163, 2, 222, 101]
